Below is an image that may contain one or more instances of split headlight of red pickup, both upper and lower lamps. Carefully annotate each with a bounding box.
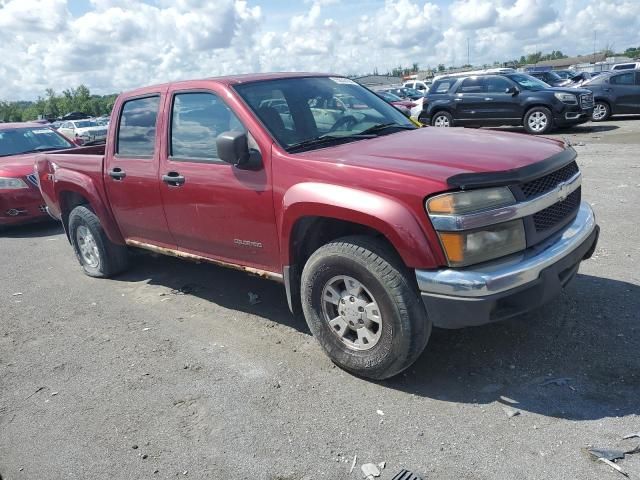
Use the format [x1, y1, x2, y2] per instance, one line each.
[426, 187, 527, 267]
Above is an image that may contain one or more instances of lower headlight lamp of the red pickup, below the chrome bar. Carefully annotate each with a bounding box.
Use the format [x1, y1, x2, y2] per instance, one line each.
[438, 220, 527, 267]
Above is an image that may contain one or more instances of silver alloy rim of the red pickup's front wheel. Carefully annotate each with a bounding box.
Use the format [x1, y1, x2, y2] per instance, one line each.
[322, 275, 382, 350]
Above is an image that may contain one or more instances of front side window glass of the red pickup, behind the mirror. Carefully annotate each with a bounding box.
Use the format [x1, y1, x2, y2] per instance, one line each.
[170, 93, 246, 161]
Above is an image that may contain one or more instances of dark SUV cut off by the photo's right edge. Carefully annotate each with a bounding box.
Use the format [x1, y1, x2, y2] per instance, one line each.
[584, 70, 640, 122]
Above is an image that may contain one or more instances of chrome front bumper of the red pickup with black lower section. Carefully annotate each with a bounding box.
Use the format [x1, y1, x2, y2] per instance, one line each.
[416, 202, 598, 328]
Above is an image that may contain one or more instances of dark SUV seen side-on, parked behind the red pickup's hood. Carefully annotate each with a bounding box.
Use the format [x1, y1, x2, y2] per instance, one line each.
[419, 73, 593, 134]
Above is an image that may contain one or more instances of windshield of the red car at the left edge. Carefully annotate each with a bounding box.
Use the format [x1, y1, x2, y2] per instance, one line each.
[0, 127, 73, 157]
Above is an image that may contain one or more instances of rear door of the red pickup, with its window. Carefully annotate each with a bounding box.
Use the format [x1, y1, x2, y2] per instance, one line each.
[105, 89, 176, 248]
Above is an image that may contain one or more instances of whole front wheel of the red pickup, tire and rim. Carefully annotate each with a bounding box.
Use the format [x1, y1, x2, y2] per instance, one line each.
[301, 236, 431, 380]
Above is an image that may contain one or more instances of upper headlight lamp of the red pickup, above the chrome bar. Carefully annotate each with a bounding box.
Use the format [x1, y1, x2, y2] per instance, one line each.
[426, 187, 516, 215]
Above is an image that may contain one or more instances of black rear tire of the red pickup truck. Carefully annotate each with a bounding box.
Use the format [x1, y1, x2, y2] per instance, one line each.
[69, 205, 129, 278]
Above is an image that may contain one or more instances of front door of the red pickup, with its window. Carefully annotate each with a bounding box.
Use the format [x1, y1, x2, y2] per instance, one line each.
[160, 90, 280, 272]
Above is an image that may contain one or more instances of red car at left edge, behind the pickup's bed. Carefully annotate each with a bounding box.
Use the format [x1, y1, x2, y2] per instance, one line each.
[0, 123, 74, 229]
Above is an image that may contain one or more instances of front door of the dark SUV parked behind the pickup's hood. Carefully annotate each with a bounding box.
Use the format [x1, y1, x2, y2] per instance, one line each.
[478, 75, 522, 123]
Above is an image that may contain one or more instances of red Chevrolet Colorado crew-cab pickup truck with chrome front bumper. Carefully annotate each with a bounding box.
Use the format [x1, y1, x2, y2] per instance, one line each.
[36, 73, 599, 379]
